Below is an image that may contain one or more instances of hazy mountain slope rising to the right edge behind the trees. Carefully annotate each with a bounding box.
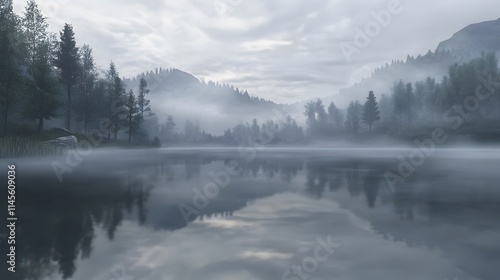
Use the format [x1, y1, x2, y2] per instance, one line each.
[312, 19, 500, 111]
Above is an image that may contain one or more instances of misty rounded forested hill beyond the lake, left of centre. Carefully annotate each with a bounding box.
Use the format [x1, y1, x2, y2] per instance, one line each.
[124, 68, 282, 134]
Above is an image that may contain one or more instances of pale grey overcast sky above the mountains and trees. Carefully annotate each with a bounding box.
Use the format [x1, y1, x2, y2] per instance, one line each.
[14, 0, 500, 103]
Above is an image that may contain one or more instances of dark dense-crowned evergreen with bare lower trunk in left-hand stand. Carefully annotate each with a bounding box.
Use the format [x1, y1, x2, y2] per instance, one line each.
[56, 23, 80, 130]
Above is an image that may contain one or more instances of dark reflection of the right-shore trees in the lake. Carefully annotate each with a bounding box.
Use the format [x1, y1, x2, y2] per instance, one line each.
[300, 160, 500, 280]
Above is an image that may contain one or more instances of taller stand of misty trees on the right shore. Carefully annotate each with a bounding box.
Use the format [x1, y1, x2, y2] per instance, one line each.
[304, 53, 500, 139]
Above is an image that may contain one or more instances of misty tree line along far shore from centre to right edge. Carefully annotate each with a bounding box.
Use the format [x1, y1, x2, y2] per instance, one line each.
[155, 49, 500, 145]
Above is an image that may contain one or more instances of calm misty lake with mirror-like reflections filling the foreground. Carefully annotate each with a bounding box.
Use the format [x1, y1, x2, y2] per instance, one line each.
[0, 147, 500, 280]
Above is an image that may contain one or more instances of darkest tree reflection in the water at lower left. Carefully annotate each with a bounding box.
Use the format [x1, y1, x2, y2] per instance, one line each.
[17, 175, 152, 279]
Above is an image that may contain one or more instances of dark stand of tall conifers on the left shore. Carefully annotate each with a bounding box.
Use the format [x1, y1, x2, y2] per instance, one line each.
[0, 0, 151, 142]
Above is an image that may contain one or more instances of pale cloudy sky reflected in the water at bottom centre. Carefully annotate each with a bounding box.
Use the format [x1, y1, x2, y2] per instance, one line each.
[68, 193, 471, 280]
